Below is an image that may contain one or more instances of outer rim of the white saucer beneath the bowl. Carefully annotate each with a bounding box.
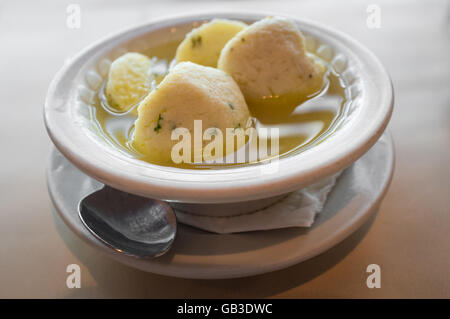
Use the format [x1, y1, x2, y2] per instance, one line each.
[46, 133, 395, 279]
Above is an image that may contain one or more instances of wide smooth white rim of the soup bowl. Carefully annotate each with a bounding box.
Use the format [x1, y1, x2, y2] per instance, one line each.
[44, 11, 394, 203]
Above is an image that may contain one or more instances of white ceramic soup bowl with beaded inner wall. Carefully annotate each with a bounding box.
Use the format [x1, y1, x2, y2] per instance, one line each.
[44, 13, 393, 210]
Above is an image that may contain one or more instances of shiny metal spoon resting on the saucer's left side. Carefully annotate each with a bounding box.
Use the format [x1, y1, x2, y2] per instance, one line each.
[78, 185, 177, 258]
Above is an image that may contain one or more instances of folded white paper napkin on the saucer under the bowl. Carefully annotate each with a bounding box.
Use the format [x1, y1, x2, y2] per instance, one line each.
[176, 173, 340, 234]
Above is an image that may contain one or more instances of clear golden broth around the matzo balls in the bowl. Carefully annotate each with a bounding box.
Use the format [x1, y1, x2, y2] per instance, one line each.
[91, 41, 348, 169]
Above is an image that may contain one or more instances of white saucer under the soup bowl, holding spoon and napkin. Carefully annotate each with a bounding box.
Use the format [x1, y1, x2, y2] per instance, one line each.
[47, 134, 394, 279]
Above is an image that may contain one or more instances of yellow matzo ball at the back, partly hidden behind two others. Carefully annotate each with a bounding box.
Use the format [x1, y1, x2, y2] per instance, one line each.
[175, 19, 247, 67]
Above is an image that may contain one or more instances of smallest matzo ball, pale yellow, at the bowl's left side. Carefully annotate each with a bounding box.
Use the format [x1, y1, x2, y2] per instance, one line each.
[105, 52, 153, 112]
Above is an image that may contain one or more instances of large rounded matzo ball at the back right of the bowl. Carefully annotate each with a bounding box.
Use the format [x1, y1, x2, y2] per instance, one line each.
[218, 17, 325, 110]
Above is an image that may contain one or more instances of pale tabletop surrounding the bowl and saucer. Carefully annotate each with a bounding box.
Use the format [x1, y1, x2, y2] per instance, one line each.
[0, 0, 450, 298]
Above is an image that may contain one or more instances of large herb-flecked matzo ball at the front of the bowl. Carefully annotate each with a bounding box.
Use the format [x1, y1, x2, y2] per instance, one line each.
[132, 62, 249, 165]
